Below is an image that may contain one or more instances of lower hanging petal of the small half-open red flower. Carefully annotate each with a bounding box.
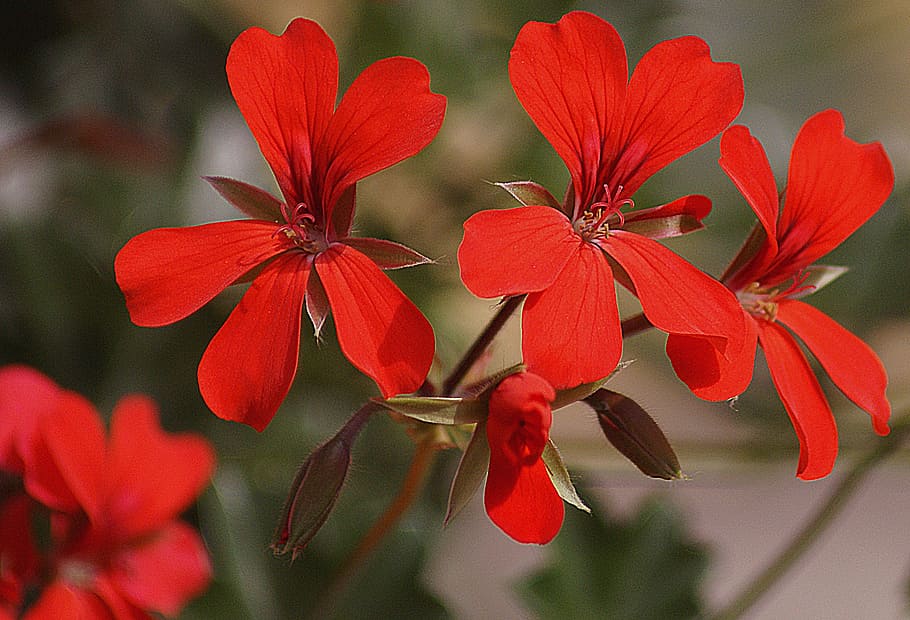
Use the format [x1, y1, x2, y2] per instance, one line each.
[484, 452, 565, 545]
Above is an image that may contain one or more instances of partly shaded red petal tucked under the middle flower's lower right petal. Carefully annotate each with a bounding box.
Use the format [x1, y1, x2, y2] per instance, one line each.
[667, 310, 758, 401]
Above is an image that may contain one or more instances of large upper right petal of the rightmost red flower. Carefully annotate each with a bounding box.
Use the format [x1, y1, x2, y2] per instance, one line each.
[766, 110, 894, 283]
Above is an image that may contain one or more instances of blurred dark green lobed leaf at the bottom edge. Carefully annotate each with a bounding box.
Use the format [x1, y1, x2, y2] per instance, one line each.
[517, 492, 708, 620]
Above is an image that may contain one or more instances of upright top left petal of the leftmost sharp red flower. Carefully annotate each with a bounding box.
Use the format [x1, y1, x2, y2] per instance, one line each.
[227, 19, 338, 206]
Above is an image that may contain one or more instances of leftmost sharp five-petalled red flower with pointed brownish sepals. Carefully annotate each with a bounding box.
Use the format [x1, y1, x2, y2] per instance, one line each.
[114, 19, 445, 430]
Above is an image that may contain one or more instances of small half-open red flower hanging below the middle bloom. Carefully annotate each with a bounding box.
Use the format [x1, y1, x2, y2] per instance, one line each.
[484, 372, 563, 545]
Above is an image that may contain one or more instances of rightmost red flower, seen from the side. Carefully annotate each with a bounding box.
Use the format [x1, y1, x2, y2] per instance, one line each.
[668, 110, 894, 480]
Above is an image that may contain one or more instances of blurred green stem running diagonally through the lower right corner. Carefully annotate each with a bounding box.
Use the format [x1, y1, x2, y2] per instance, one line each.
[711, 414, 910, 620]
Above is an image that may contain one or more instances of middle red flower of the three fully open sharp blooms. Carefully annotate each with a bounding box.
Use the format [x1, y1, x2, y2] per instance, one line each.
[458, 12, 743, 396]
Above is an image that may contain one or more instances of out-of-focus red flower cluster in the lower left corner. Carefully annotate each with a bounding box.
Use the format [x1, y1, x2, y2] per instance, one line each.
[0, 366, 215, 620]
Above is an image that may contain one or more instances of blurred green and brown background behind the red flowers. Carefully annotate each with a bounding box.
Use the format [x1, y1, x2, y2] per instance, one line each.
[0, 0, 910, 618]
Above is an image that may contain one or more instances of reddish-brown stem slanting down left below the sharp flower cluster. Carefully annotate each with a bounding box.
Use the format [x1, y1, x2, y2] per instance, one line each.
[312, 435, 437, 618]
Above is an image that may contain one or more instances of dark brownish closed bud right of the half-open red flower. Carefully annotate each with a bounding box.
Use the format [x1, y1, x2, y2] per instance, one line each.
[585, 388, 685, 480]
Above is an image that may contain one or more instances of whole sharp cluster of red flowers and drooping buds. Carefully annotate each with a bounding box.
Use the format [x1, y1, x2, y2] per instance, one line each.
[110, 12, 893, 553]
